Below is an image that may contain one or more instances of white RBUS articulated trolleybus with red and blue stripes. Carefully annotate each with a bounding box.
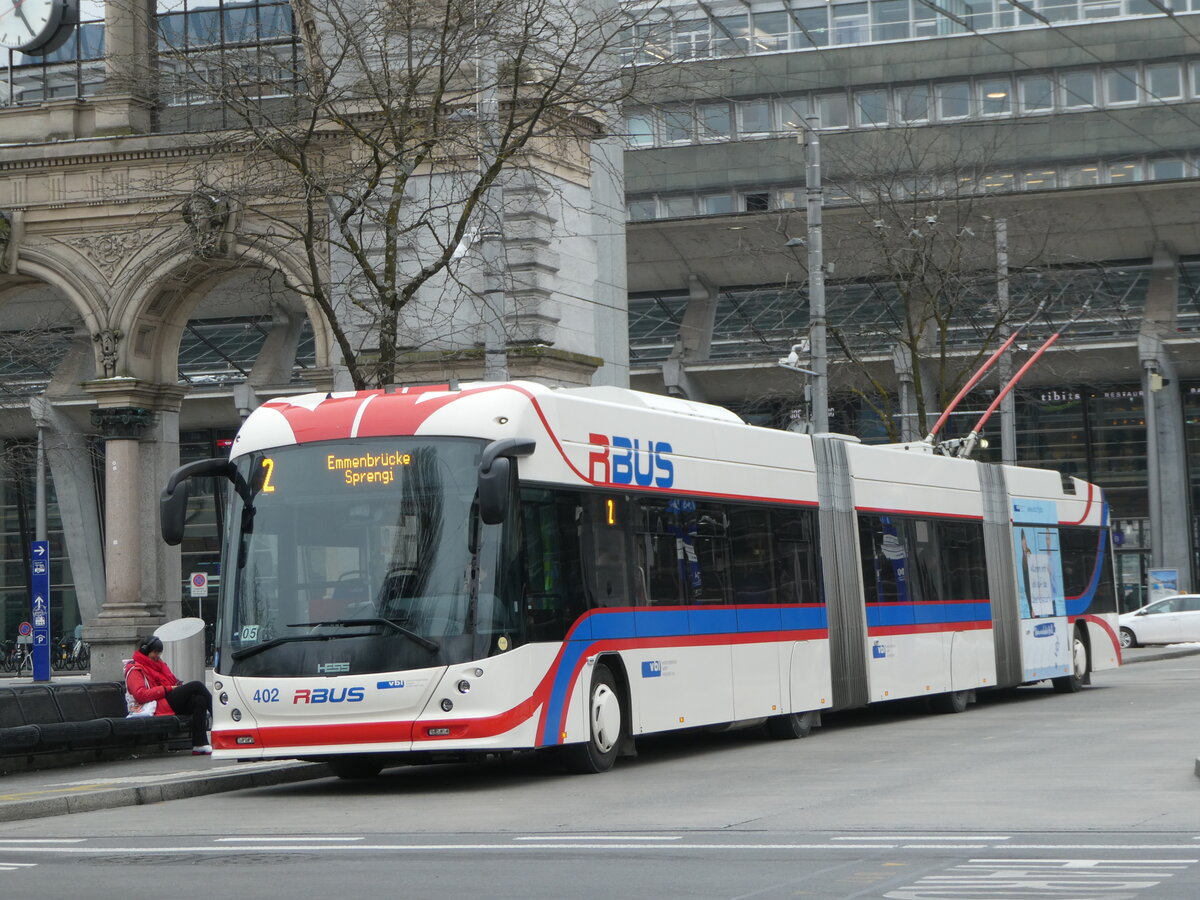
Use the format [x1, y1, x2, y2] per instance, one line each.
[162, 382, 1120, 778]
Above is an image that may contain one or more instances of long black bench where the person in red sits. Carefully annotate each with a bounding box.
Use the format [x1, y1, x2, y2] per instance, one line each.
[0, 682, 191, 772]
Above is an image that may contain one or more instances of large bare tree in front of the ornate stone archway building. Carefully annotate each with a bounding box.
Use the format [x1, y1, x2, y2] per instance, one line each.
[163, 0, 657, 389]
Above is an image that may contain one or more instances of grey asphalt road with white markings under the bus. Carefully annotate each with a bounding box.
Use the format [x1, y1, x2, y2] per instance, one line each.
[0, 656, 1200, 900]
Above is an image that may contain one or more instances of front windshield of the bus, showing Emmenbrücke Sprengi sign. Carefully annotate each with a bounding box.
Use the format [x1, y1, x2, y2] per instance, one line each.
[216, 437, 520, 677]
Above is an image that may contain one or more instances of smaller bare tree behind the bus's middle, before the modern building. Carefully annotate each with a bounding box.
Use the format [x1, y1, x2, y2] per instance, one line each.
[806, 128, 1062, 440]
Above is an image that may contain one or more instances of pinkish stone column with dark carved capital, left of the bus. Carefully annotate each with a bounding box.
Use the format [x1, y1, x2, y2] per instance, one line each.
[84, 378, 185, 682]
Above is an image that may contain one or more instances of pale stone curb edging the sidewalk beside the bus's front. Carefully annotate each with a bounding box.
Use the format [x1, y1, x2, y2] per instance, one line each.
[0, 762, 331, 822]
